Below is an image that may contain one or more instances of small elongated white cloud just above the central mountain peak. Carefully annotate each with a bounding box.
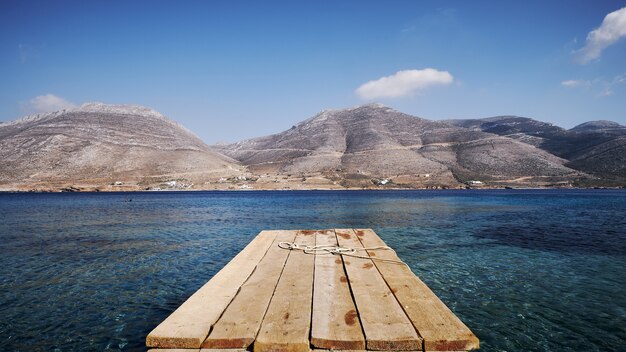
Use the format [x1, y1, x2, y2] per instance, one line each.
[356, 68, 454, 100]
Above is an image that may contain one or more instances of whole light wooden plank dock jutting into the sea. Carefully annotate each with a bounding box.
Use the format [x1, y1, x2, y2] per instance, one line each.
[146, 229, 479, 352]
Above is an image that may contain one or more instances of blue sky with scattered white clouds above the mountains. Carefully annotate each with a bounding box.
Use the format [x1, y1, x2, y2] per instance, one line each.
[0, 0, 626, 143]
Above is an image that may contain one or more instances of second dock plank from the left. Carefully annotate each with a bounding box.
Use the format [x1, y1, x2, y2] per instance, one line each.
[202, 231, 296, 348]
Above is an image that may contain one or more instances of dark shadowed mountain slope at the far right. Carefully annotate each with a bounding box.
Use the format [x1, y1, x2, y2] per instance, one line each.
[447, 116, 626, 179]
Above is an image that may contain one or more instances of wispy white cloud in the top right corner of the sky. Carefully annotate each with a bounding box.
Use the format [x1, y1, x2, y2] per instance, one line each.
[577, 7, 626, 64]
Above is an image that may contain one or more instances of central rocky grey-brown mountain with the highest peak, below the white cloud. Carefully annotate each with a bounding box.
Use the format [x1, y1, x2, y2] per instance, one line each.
[214, 104, 584, 187]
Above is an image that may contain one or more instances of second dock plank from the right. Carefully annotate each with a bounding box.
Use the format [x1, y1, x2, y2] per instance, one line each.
[335, 229, 422, 351]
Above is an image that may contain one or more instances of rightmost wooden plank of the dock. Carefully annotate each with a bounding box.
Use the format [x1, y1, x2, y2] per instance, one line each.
[356, 229, 479, 351]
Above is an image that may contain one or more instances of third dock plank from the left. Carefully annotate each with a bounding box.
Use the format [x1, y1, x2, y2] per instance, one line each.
[254, 231, 315, 352]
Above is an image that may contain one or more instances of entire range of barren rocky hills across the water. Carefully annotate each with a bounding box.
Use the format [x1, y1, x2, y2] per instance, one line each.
[0, 103, 626, 191]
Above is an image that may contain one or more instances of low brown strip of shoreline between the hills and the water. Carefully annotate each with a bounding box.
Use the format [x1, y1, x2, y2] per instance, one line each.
[0, 172, 626, 193]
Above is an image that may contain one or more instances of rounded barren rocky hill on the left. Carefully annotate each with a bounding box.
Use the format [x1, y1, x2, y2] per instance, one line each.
[0, 103, 242, 189]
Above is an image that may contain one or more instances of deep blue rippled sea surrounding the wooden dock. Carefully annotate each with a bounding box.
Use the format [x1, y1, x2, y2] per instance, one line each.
[0, 190, 626, 352]
